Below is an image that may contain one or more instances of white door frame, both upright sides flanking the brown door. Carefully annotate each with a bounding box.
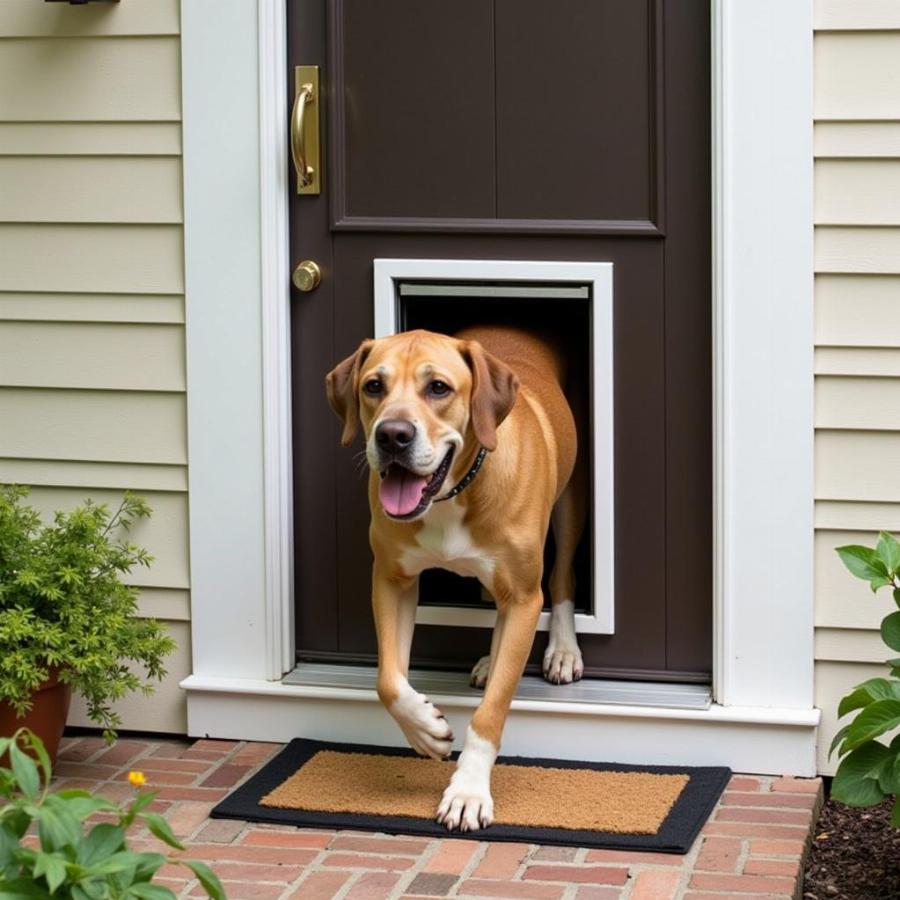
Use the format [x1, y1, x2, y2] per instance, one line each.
[182, 0, 818, 774]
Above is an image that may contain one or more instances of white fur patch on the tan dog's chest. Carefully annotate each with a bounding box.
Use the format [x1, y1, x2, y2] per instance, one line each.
[400, 503, 494, 587]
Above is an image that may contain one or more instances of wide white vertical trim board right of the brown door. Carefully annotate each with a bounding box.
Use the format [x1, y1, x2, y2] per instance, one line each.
[713, 0, 814, 708]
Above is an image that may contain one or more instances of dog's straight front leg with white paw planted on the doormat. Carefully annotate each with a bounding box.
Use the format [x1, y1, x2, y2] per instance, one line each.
[437, 590, 543, 831]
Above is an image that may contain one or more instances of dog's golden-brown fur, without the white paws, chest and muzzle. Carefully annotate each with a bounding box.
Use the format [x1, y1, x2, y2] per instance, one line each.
[327, 327, 587, 827]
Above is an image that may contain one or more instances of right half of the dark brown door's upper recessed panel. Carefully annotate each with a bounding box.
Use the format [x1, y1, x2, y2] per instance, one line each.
[496, 0, 659, 224]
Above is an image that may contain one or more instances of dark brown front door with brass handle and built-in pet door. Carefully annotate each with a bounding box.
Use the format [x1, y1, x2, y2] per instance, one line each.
[288, 0, 712, 680]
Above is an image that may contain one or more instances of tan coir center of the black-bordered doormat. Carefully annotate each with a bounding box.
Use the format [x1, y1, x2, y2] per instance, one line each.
[259, 750, 689, 834]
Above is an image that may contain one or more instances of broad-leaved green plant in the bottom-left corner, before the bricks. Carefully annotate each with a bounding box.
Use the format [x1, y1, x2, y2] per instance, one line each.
[0, 728, 225, 900]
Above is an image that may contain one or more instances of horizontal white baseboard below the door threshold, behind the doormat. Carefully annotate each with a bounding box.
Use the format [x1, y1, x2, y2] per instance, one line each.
[181, 675, 819, 776]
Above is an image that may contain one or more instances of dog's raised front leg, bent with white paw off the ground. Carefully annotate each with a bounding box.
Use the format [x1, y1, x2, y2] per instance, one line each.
[372, 565, 453, 759]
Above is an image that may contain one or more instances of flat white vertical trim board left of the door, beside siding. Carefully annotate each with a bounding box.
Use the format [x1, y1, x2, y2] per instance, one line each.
[182, 0, 270, 678]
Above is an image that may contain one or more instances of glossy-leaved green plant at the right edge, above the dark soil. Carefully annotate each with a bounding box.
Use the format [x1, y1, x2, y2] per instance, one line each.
[829, 532, 900, 828]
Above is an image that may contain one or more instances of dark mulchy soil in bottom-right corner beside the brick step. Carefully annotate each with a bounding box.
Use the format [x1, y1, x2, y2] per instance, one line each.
[803, 800, 900, 900]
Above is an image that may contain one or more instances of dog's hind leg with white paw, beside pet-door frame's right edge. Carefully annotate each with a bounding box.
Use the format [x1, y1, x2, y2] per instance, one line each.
[542, 453, 589, 684]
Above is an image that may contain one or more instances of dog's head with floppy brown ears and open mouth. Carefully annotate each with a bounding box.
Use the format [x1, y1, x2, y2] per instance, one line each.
[325, 331, 518, 520]
